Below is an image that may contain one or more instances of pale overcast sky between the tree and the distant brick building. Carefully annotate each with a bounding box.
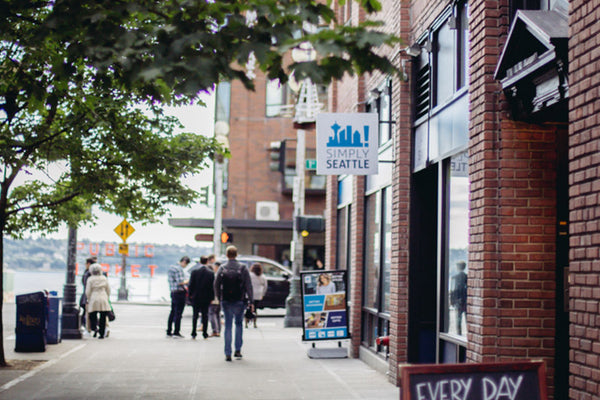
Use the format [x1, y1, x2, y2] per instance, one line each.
[27, 95, 214, 245]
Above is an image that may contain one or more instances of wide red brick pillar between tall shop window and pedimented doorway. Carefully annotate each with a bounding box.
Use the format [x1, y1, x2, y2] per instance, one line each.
[467, 1, 559, 393]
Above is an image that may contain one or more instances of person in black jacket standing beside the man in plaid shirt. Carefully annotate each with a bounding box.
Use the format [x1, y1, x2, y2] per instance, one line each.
[188, 257, 215, 339]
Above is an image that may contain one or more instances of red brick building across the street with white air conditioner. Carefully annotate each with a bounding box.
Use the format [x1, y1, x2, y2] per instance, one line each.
[170, 73, 325, 268]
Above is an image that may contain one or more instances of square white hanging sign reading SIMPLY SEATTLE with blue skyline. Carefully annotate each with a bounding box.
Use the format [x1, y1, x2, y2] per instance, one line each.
[317, 113, 379, 175]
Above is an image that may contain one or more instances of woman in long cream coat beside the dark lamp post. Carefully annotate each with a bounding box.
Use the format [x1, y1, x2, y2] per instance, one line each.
[85, 263, 111, 339]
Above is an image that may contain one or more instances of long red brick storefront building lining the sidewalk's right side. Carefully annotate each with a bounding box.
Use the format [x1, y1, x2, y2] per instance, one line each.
[325, 0, 600, 399]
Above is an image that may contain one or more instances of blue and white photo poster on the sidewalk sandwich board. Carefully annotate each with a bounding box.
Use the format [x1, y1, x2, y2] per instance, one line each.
[300, 270, 350, 341]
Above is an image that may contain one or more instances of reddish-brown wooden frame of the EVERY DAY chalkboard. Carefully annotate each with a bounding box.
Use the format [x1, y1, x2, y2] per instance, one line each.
[399, 361, 548, 400]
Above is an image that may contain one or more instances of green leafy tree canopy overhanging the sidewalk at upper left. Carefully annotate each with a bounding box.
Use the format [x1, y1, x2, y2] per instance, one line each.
[0, 0, 404, 365]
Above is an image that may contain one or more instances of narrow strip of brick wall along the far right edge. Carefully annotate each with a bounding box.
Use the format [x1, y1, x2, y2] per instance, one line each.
[569, 0, 600, 400]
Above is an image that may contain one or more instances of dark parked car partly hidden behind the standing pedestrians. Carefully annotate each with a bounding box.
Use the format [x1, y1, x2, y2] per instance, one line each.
[218, 255, 293, 308]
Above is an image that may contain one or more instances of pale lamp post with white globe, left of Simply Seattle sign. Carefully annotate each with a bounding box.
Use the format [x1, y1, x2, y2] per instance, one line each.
[283, 43, 322, 327]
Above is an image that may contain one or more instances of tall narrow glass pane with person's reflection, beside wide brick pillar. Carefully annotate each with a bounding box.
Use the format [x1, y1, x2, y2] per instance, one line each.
[444, 153, 469, 336]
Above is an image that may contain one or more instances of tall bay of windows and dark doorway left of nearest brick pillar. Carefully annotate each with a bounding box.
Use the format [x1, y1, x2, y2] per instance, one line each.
[410, 2, 469, 363]
